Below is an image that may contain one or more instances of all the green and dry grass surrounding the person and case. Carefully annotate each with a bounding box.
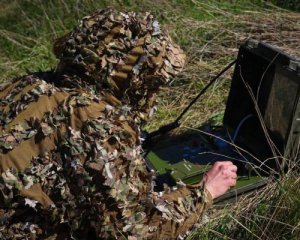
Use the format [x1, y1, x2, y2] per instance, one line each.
[0, 0, 300, 239]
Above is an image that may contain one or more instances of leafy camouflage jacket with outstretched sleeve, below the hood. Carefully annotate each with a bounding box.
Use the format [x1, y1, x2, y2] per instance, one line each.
[0, 74, 211, 239]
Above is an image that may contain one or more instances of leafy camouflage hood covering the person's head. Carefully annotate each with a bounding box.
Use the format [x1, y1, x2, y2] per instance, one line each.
[54, 8, 185, 117]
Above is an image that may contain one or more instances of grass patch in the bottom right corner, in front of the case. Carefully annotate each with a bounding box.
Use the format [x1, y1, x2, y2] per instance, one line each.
[188, 177, 300, 240]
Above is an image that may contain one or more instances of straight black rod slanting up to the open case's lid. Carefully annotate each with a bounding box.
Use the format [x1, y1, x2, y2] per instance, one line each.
[146, 60, 236, 140]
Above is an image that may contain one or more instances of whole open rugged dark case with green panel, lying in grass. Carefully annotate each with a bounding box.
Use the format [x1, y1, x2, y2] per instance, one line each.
[145, 40, 300, 198]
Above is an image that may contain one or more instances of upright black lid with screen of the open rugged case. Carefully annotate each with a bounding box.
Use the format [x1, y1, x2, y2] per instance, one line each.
[223, 40, 300, 158]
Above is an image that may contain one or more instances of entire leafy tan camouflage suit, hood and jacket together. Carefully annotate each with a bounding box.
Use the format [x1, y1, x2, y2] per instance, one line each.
[0, 9, 212, 240]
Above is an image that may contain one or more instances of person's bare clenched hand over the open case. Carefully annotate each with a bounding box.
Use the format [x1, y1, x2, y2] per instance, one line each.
[203, 161, 237, 199]
